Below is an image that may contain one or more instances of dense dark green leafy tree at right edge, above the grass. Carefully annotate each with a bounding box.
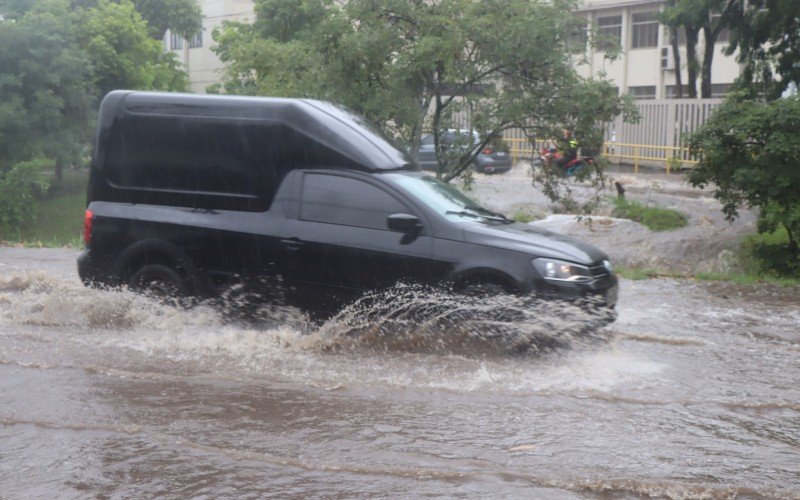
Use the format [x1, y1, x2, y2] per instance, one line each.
[688, 93, 800, 258]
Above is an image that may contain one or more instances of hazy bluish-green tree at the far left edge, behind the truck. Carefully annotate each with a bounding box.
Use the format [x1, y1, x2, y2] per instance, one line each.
[0, 0, 93, 174]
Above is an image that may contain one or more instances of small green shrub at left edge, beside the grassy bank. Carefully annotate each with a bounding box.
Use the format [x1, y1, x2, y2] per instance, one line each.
[0, 160, 49, 229]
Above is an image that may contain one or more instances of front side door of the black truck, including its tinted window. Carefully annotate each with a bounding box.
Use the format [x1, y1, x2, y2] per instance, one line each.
[281, 172, 433, 309]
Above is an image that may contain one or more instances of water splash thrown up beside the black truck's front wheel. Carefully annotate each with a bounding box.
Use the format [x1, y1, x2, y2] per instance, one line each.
[318, 285, 614, 354]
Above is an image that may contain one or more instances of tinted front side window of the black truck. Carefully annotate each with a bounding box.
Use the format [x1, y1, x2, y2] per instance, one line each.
[300, 174, 409, 231]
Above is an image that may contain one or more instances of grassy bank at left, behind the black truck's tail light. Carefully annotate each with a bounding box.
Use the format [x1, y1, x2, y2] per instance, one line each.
[0, 169, 89, 248]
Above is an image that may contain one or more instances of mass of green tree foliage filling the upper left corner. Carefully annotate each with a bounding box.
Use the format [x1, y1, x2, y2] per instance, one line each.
[0, 0, 187, 191]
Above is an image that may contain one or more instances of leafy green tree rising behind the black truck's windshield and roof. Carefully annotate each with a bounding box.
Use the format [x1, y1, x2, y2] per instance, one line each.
[214, 0, 636, 186]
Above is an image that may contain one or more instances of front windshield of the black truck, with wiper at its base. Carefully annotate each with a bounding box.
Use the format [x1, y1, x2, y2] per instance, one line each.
[382, 173, 510, 222]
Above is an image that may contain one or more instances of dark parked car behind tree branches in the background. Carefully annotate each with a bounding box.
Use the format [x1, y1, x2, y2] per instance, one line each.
[414, 130, 512, 174]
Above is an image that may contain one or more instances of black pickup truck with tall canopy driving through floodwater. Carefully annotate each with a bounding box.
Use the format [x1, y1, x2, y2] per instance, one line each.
[78, 91, 617, 318]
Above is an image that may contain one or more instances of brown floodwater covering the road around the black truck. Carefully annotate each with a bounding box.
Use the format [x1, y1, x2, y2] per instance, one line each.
[0, 248, 800, 498]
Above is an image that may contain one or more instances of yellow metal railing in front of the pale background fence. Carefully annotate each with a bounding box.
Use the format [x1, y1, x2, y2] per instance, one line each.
[504, 138, 697, 174]
